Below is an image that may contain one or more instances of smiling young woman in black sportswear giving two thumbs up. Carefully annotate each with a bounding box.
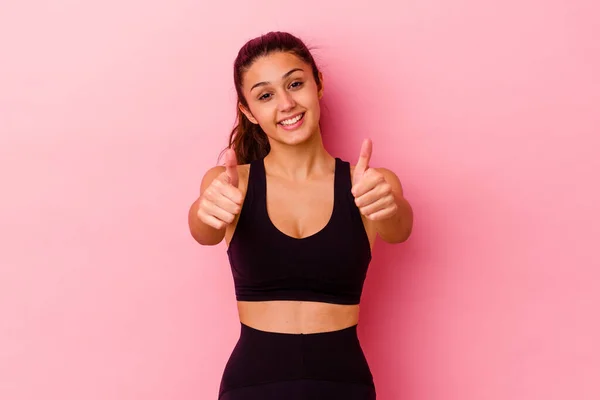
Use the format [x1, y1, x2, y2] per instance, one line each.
[189, 32, 413, 400]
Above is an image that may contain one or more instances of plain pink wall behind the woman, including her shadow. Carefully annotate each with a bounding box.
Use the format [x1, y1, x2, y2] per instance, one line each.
[0, 0, 600, 400]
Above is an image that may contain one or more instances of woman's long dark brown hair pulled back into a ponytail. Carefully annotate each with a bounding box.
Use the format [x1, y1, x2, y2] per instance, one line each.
[223, 32, 321, 164]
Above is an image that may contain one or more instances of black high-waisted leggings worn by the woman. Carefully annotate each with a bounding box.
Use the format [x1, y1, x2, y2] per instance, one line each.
[219, 324, 375, 400]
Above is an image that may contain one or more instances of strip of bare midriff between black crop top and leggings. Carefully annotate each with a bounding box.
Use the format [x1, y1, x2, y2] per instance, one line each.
[237, 300, 359, 334]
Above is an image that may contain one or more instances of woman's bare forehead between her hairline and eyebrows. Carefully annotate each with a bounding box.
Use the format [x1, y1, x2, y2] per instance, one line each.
[243, 52, 310, 88]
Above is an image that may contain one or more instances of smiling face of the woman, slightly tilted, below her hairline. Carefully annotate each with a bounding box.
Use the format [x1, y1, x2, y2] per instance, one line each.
[240, 52, 323, 145]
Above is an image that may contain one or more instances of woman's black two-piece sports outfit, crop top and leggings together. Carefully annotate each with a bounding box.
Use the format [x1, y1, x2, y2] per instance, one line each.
[219, 158, 375, 400]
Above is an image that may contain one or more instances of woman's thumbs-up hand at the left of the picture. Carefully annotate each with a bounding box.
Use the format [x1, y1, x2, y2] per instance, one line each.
[198, 149, 244, 229]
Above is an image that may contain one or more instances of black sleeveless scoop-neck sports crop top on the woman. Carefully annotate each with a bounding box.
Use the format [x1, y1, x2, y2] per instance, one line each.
[227, 157, 371, 304]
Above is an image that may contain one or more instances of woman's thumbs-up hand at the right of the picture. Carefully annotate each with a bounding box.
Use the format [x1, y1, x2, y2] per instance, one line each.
[352, 139, 398, 221]
